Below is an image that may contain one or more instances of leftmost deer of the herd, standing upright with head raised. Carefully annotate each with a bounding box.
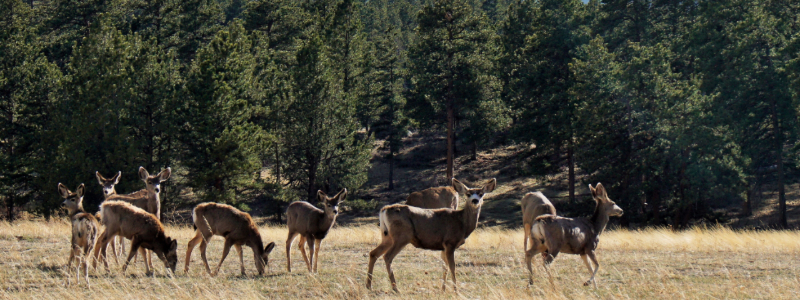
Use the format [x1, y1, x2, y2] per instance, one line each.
[58, 183, 100, 285]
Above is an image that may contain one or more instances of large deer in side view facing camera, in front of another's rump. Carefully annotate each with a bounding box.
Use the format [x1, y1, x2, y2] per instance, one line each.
[367, 178, 497, 292]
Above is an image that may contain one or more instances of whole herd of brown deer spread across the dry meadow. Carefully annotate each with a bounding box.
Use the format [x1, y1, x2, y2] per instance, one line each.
[58, 167, 622, 292]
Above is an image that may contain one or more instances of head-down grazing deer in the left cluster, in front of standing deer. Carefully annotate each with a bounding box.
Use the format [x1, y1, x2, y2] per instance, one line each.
[93, 201, 178, 274]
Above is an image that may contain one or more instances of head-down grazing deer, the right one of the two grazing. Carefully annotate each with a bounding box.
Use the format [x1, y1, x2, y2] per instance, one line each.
[183, 202, 275, 276]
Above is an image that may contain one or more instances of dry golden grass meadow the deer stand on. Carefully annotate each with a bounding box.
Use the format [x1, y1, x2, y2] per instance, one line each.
[0, 221, 800, 299]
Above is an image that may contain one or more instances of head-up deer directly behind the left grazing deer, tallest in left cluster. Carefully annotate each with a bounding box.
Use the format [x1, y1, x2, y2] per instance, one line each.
[101, 167, 172, 268]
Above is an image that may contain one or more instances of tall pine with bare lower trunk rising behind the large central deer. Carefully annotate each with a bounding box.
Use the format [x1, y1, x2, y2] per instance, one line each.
[409, 0, 504, 178]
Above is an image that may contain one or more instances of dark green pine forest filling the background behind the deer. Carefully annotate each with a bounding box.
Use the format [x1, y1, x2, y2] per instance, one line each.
[0, 0, 800, 228]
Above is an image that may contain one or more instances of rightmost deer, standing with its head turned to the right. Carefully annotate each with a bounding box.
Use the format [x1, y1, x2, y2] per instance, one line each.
[525, 183, 623, 288]
